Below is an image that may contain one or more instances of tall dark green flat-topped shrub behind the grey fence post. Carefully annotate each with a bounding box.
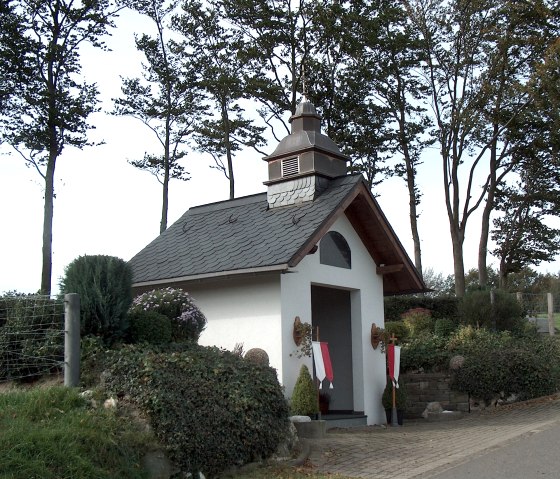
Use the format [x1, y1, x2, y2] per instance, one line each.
[60, 255, 132, 344]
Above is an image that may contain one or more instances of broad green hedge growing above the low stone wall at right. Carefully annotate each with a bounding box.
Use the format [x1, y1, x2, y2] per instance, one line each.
[401, 326, 560, 400]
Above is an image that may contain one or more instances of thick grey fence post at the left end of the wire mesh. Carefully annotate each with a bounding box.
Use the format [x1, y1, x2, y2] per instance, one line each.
[64, 293, 80, 387]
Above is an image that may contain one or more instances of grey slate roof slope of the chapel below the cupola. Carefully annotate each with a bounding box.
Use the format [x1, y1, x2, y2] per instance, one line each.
[130, 174, 364, 285]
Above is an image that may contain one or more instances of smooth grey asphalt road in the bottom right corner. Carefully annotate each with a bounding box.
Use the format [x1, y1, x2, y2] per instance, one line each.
[426, 423, 560, 479]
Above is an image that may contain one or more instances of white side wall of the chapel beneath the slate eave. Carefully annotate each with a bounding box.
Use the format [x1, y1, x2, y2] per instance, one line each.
[185, 273, 283, 380]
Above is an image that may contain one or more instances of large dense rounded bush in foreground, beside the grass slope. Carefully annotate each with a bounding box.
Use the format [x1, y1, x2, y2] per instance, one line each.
[103, 342, 289, 477]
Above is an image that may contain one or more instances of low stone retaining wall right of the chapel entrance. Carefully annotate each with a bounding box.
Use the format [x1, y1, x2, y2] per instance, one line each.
[401, 373, 469, 418]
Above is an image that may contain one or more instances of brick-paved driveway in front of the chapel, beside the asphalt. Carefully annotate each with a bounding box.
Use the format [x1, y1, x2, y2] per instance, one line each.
[310, 396, 560, 479]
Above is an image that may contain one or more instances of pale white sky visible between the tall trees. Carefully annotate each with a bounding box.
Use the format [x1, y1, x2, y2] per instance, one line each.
[0, 12, 560, 293]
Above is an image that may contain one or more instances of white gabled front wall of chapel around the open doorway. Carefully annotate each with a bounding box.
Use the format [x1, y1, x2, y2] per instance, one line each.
[280, 216, 385, 424]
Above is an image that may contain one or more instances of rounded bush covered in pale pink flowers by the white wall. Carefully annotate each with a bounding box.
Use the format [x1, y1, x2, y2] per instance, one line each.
[129, 287, 206, 341]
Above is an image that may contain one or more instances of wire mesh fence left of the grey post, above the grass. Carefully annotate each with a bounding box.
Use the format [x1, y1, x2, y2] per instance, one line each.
[0, 295, 64, 382]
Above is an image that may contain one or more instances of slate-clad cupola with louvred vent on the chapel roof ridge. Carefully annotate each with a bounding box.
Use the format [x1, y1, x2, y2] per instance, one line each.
[263, 99, 349, 208]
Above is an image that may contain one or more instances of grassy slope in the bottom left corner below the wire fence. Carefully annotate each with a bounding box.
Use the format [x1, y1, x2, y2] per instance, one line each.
[0, 387, 151, 479]
